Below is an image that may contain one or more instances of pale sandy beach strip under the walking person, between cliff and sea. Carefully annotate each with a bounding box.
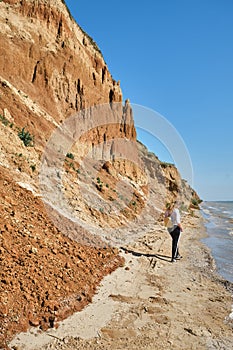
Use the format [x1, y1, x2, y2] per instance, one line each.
[10, 213, 233, 350]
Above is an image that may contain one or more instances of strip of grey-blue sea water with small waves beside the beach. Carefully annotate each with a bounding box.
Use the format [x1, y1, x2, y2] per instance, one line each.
[201, 201, 233, 282]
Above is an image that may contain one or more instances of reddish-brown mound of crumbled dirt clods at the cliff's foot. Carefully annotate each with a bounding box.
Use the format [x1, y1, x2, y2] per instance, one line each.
[0, 168, 123, 347]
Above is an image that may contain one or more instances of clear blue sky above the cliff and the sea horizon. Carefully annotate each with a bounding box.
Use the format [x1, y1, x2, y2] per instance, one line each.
[66, 0, 233, 200]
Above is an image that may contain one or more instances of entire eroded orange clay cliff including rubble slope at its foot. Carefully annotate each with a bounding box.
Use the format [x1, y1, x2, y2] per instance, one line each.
[0, 0, 198, 346]
